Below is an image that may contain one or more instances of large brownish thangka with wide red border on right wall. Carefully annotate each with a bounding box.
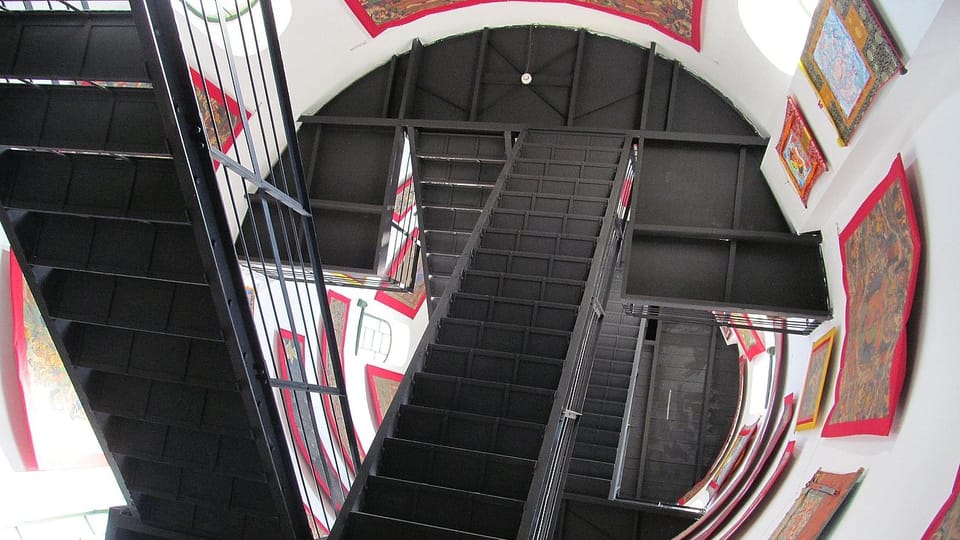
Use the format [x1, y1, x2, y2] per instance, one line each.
[822, 156, 920, 437]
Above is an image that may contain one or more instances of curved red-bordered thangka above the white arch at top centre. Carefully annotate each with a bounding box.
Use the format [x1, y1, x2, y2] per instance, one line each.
[346, 0, 703, 50]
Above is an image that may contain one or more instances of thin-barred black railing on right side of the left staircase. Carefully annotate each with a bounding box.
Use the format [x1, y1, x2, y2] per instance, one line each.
[146, 0, 360, 538]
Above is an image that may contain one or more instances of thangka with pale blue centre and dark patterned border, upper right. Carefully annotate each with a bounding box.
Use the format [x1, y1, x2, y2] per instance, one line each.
[800, 0, 904, 145]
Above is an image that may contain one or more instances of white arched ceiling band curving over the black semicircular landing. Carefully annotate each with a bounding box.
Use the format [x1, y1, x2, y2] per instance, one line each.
[281, 0, 790, 135]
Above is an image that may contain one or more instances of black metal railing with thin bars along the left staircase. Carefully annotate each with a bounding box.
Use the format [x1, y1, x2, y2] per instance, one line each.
[141, 0, 360, 537]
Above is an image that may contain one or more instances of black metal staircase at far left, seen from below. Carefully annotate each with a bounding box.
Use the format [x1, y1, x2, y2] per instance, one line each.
[0, 5, 306, 539]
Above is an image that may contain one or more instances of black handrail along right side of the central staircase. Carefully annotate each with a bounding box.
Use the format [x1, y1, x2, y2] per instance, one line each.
[517, 138, 636, 540]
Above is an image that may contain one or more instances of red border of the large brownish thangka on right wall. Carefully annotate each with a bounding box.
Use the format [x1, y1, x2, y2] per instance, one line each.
[820, 154, 921, 437]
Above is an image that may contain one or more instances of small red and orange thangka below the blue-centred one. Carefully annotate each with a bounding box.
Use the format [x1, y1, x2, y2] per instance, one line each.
[777, 96, 827, 206]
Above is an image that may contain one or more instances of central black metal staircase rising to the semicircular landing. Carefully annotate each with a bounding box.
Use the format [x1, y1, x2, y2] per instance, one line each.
[333, 130, 629, 539]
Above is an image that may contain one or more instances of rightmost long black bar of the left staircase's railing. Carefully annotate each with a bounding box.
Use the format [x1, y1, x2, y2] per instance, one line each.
[260, 0, 360, 463]
